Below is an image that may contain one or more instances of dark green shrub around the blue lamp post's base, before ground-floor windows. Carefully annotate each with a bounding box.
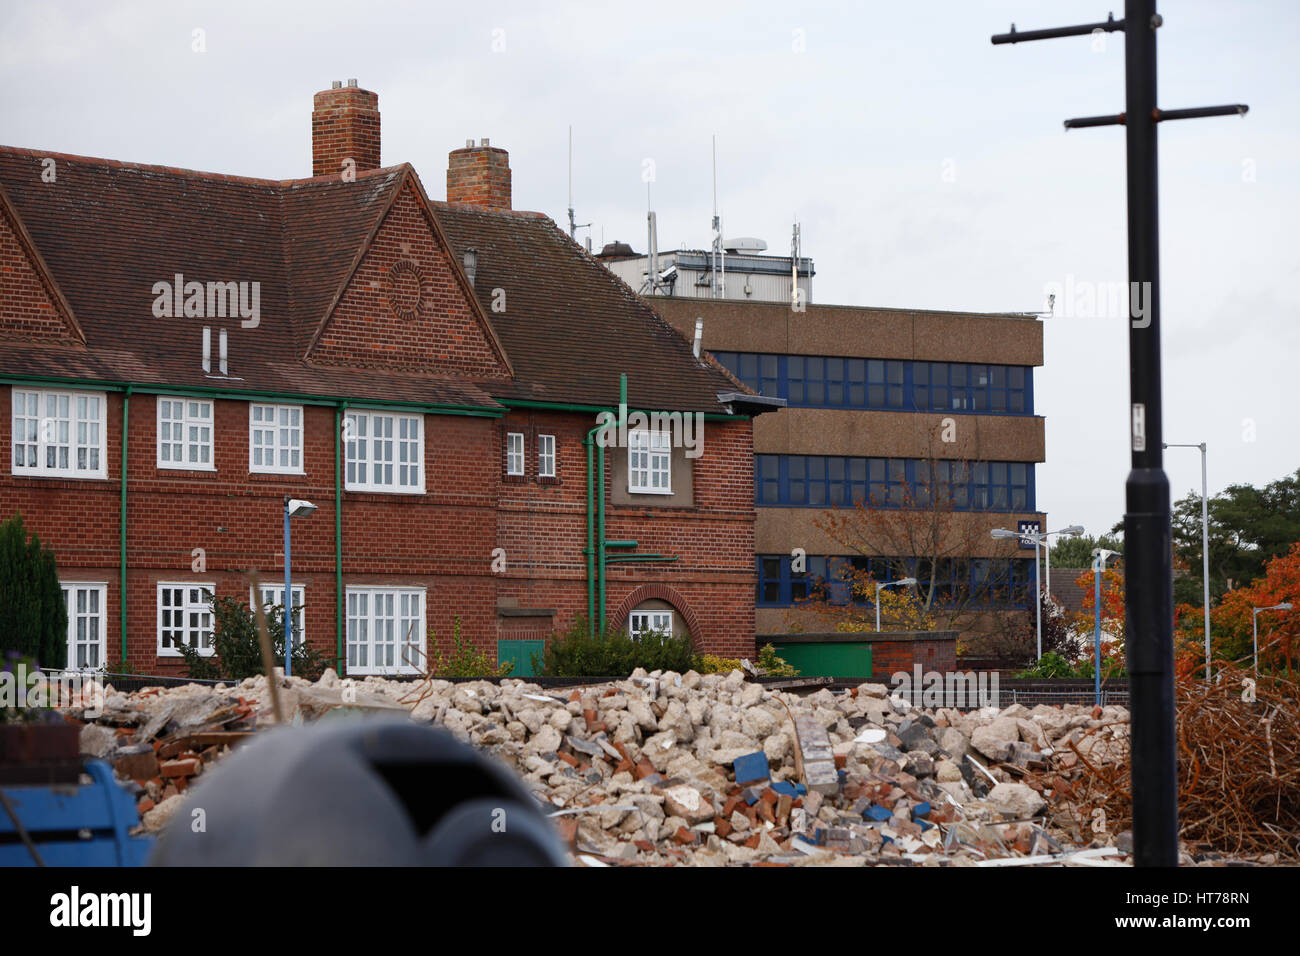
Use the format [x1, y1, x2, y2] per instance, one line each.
[181, 592, 329, 682]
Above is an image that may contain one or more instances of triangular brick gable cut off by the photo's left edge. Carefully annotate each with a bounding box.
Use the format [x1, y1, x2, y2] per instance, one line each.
[0, 180, 86, 346]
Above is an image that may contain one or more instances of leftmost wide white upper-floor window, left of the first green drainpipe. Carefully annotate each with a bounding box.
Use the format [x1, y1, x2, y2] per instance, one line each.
[12, 386, 108, 477]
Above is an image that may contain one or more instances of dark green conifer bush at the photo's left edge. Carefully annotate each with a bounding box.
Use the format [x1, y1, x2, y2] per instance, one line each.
[0, 514, 68, 669]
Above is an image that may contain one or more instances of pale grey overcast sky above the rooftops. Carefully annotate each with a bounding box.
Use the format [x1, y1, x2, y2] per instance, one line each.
[0, 0, 1300, 532]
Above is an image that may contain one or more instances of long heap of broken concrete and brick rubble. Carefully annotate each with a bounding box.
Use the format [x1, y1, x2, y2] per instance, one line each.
[73, 670, 1128, 866]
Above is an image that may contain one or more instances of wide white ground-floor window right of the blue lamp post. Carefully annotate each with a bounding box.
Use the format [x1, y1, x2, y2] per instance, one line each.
[346, 588, 425, 674]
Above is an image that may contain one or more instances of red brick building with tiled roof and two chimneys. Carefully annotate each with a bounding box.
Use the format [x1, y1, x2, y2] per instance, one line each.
[0, 85, 771, 674]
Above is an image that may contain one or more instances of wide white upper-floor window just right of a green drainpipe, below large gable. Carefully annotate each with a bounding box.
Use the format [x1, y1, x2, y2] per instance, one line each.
[343, 411, 424, 494]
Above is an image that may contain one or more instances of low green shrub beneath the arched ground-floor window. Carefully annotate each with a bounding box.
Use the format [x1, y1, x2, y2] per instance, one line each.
[533, 618, 696, 678]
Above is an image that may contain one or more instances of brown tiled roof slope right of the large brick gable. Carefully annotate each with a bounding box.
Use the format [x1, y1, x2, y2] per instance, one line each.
[430, 203, 745, 412]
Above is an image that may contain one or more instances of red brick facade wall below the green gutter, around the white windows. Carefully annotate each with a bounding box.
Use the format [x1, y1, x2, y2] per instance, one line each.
[0, 388, 754, 674]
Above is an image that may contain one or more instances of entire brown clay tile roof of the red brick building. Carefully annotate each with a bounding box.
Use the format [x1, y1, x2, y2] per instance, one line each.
[0, 147, 746, 411]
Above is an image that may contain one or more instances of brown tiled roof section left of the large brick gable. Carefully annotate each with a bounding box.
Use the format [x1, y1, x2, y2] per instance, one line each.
[0, 147, 501, 408]
